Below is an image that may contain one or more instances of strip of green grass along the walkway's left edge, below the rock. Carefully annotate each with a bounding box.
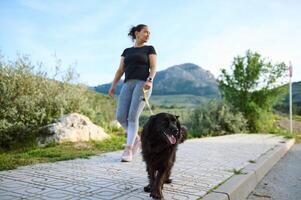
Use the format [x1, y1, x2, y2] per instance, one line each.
[0, 135, 126, 171]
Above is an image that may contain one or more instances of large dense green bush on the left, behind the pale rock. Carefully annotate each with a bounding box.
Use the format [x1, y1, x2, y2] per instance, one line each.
[0, 56, 115, 148]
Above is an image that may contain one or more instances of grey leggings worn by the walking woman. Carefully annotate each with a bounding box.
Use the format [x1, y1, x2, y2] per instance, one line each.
[116, 80, 152, 145]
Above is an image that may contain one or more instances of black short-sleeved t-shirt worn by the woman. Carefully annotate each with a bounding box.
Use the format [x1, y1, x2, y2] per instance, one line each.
[121, 45, 156, 82]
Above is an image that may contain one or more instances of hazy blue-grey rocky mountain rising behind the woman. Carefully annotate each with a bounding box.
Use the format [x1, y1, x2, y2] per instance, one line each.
[91, 63, 219, 98]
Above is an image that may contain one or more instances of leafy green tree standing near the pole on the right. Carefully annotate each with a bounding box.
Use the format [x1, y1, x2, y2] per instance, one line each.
[219, 50, 287, 132]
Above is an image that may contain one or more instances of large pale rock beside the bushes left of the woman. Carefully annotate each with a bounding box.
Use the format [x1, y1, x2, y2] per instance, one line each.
[37, 113, 110, 146]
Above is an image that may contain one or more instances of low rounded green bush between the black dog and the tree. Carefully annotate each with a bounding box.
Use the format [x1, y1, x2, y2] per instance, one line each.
[187, 101, 246, 137]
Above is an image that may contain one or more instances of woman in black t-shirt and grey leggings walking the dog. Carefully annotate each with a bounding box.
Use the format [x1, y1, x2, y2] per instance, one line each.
[109, 24, 156, 162]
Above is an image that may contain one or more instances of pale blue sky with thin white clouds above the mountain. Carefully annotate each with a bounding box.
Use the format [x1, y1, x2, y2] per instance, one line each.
[0, 0, 301, 86]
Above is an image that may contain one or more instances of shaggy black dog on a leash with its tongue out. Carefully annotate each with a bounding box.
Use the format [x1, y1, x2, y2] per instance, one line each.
[141, 113, 187, 199]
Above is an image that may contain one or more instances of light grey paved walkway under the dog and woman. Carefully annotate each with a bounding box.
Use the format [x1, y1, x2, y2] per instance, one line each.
[0, 134, 283, 200]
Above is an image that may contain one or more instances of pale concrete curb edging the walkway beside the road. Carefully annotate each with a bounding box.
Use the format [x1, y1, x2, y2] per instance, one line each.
[202, 139, 295, 200]
